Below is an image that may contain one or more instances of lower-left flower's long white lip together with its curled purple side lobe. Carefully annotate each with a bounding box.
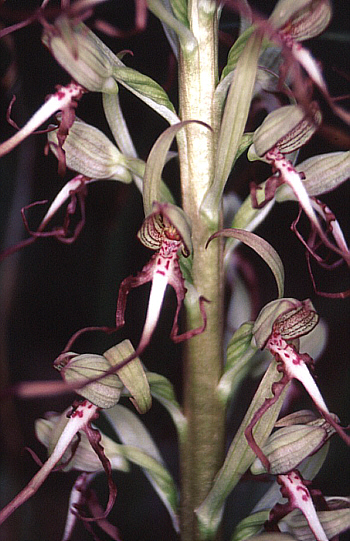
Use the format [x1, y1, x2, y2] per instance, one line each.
[0, 400, 116, 524]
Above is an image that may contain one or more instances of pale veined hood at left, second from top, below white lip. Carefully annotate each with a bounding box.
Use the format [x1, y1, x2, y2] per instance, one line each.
[47, 119, 132, 183]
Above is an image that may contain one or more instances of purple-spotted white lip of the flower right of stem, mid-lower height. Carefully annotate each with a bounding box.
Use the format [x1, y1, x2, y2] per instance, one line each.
[266, 332, 329, 414]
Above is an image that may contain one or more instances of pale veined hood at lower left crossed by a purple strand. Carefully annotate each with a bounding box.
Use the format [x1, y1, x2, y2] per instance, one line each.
[54, 352, 123, 409]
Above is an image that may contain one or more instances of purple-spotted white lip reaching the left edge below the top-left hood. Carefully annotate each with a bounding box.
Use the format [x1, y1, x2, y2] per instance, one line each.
[0, 83, 84, 157]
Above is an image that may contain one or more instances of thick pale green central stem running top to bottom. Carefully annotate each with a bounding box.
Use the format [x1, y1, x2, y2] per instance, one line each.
[178, 0, 225, 541]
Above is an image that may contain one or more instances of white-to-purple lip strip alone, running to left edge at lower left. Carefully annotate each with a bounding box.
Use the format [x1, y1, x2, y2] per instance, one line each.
[0, 400, 98, 524]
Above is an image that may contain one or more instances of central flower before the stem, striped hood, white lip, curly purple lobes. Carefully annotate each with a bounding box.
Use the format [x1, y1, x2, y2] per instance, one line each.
[116, 203, 206, 355]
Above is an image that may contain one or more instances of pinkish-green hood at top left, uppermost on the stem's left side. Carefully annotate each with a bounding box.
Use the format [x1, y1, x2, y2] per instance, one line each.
[42, 16, 118, 94]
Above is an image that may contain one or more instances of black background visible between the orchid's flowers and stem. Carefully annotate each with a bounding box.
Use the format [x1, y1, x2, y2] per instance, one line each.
[0, 1, 350, 541]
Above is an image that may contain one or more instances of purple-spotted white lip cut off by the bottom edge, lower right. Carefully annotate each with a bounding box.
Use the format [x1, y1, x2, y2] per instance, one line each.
[277, 470, 328, 541]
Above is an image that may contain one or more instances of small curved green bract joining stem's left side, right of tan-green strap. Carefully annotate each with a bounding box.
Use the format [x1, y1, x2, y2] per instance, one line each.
[146, 372, 187, 441]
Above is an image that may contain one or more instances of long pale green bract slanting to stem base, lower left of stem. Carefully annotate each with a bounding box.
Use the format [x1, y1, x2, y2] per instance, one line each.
[104, 404, 178, 531]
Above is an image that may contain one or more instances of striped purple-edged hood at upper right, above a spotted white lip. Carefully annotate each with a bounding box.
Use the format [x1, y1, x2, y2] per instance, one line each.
[253, 102, 322, 157]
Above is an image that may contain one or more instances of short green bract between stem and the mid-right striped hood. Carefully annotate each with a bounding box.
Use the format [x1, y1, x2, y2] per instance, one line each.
[218, 321, 257, 404]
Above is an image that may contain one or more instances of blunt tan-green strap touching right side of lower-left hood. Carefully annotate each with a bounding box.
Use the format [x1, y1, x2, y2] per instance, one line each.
[103, 340, 152, 413]
